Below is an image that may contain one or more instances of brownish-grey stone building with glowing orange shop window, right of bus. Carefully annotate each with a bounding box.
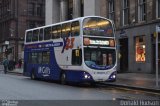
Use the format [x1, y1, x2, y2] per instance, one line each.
[100, 0, 160, 73]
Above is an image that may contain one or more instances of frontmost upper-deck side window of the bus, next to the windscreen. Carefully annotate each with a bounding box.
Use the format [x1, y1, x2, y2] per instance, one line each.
[71, 21, 80, 36]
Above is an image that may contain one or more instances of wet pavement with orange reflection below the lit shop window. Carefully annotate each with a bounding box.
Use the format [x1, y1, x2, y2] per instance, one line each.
[105, 73, 160, 92]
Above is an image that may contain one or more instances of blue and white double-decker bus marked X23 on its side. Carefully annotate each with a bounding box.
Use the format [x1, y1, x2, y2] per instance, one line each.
[24, 16, 117, 84]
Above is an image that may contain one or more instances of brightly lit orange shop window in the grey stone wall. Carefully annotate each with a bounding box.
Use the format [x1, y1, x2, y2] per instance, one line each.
[135, 36, 146, 62]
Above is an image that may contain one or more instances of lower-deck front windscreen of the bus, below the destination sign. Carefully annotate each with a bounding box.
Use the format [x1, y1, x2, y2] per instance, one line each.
[84, 48, 116, 67]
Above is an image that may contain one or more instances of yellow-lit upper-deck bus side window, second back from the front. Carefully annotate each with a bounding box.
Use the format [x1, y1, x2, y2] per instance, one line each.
[62, 23, 71, 38]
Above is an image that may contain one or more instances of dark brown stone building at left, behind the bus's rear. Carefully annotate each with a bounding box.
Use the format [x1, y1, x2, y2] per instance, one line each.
[0, 0, 45, 61]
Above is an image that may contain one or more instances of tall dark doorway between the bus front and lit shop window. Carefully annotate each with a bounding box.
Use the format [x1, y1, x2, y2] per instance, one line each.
[119, 38, 128, 72]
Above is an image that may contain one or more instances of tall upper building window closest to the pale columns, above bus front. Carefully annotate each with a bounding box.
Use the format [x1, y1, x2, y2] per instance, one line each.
[108, 0, 115, 20]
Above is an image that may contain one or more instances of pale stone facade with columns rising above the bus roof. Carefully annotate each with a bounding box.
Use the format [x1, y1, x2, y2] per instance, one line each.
[45, 0, 100, 25]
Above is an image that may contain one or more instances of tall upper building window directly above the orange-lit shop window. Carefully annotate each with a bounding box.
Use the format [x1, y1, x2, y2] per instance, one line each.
[138, 0, 146, 21]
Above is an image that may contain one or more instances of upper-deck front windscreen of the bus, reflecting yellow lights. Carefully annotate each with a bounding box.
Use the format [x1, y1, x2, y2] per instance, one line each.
[83, 17, 114, 37]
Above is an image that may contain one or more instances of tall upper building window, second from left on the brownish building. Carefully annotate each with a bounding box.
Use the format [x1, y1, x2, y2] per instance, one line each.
[122, 0, 129, 25]
